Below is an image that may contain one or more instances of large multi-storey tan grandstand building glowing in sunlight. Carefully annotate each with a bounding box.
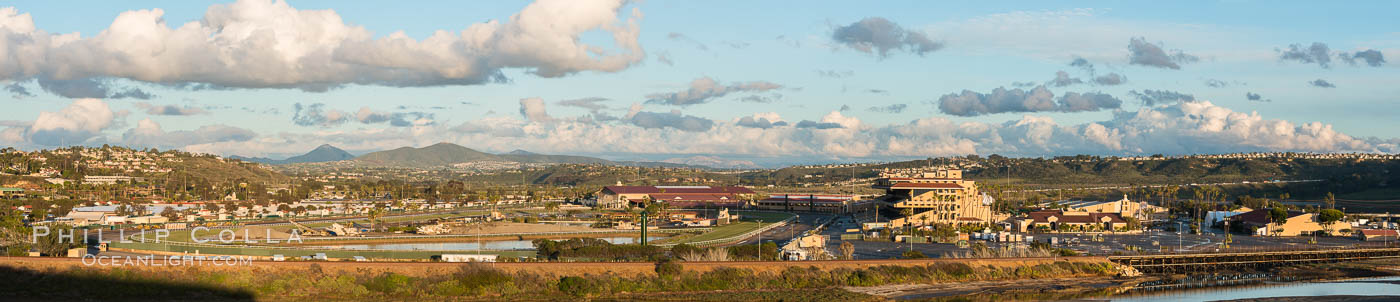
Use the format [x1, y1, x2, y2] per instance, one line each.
[872, 169, 995, 227]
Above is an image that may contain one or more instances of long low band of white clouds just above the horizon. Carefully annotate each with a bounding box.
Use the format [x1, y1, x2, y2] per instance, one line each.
[166, 101, 1400, 158]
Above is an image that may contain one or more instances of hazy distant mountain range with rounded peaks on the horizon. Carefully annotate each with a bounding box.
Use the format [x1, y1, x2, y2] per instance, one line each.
[230, 143, 708, 168]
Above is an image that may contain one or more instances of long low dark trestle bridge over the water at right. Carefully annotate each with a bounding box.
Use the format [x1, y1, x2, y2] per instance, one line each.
[1109, 247, 1400, 273]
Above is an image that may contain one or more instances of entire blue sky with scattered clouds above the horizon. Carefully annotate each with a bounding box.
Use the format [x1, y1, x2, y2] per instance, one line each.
[0, 0, 1400, 165]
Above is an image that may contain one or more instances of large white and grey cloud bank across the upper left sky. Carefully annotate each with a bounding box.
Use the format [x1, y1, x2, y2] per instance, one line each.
[0, 0, 645, 94]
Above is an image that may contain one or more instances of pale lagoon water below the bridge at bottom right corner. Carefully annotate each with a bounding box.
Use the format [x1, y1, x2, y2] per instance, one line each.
[1112, 277, 1400, 302]
